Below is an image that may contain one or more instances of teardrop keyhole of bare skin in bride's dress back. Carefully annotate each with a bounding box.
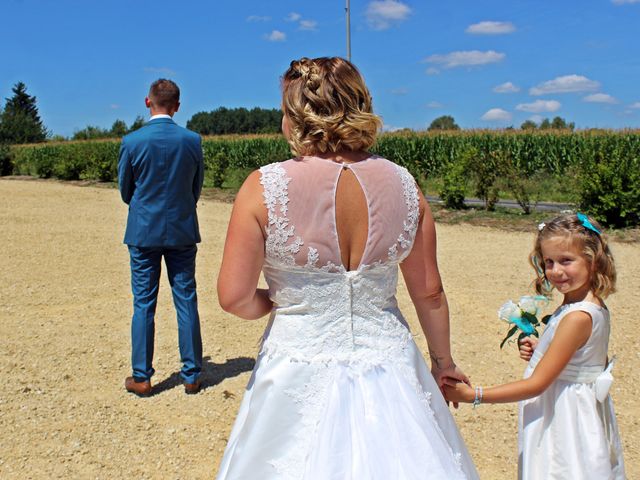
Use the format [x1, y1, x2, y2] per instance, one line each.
[335, 166, 369, 270]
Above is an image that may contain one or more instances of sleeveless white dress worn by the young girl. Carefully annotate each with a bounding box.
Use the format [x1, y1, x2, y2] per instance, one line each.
[518, 302, 625, 480]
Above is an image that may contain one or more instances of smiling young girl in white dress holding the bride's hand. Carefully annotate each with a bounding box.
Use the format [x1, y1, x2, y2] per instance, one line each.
[444, 213, 625, 480]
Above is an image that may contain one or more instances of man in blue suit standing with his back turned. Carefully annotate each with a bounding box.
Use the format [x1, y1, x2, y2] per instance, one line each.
[118, 79, 204, 396]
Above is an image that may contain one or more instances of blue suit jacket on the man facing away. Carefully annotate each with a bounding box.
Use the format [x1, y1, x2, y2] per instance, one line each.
[118, 118, 204, 247]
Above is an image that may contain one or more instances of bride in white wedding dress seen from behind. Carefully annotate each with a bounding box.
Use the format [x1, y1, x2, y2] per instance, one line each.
[217, 57, 478, 480]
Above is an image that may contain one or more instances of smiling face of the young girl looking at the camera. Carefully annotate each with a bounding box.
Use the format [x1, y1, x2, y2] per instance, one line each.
[540, 237, 591, 302]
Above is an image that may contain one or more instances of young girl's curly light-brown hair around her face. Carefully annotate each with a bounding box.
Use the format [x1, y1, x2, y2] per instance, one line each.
[529, 214, 616, 298]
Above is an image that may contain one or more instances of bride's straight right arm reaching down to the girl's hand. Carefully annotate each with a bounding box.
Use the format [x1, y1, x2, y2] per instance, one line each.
[400, 193, 469, 386]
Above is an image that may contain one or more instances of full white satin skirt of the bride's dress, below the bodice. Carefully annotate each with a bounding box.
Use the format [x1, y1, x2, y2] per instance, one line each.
[217, 341, 478, 480]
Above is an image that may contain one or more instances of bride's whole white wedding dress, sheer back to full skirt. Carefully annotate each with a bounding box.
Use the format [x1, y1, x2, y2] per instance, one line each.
[217, 157, 478, 480]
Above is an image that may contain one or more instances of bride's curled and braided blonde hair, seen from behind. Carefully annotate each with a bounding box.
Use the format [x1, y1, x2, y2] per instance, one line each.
[282, 57, 382, 155]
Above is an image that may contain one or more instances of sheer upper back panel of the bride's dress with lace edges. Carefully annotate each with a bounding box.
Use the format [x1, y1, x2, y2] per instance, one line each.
[260, 156, 419, 272]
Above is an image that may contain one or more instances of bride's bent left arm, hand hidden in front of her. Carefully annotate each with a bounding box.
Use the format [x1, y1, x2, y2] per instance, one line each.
[218, 171, 273, 320]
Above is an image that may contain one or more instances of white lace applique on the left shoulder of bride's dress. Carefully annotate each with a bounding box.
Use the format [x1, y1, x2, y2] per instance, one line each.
[260, 163, 303, 265]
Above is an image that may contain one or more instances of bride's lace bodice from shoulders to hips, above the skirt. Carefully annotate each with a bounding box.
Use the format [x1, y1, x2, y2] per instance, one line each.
[261, 157, 419, 363]
